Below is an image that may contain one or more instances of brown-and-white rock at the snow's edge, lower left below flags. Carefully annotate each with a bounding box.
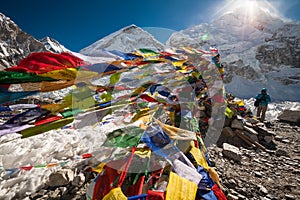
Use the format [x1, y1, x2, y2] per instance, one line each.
[48, 169, 74, 187]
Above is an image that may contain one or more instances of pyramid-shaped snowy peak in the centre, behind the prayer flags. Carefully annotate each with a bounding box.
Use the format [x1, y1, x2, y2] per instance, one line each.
[80, 24, 164, 56]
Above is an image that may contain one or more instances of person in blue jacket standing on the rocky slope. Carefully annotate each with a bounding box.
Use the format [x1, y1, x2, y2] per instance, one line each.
[255, 88, 271, 122]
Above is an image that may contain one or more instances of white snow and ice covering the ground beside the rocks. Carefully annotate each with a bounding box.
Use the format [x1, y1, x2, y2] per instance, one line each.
[0, 98, 300, 199]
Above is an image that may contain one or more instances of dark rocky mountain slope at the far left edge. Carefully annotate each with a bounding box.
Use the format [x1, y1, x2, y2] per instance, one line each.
[0, 13, 47, 70]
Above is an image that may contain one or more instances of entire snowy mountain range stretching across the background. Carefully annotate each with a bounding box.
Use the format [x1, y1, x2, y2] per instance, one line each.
[0, 9, 300, 101]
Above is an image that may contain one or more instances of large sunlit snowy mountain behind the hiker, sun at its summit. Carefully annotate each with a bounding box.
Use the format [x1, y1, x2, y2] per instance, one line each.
[167, 5, 300, 101]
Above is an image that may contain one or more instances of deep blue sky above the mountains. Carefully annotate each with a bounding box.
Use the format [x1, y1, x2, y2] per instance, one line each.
[0, 0, 300, 51]
